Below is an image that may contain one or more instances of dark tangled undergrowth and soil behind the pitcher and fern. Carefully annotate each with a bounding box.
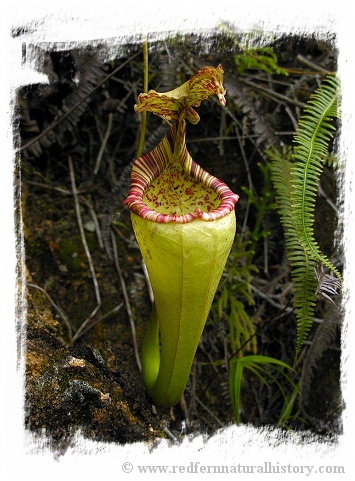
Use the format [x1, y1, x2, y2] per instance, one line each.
[17, 26, 342, 446]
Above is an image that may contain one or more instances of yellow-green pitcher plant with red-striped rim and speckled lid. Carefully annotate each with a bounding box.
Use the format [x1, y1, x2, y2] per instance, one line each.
[124, 65, 238, 407]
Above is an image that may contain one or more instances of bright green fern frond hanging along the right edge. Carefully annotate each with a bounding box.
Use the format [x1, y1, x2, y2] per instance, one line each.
[267, 76, 341, 358]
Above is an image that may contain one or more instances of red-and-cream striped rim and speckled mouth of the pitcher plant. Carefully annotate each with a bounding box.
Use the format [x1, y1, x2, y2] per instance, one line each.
[124, 124, 239, 224]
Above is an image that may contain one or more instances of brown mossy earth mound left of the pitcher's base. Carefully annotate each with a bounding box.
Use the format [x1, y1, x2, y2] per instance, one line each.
[25, 286, 167, 451]
